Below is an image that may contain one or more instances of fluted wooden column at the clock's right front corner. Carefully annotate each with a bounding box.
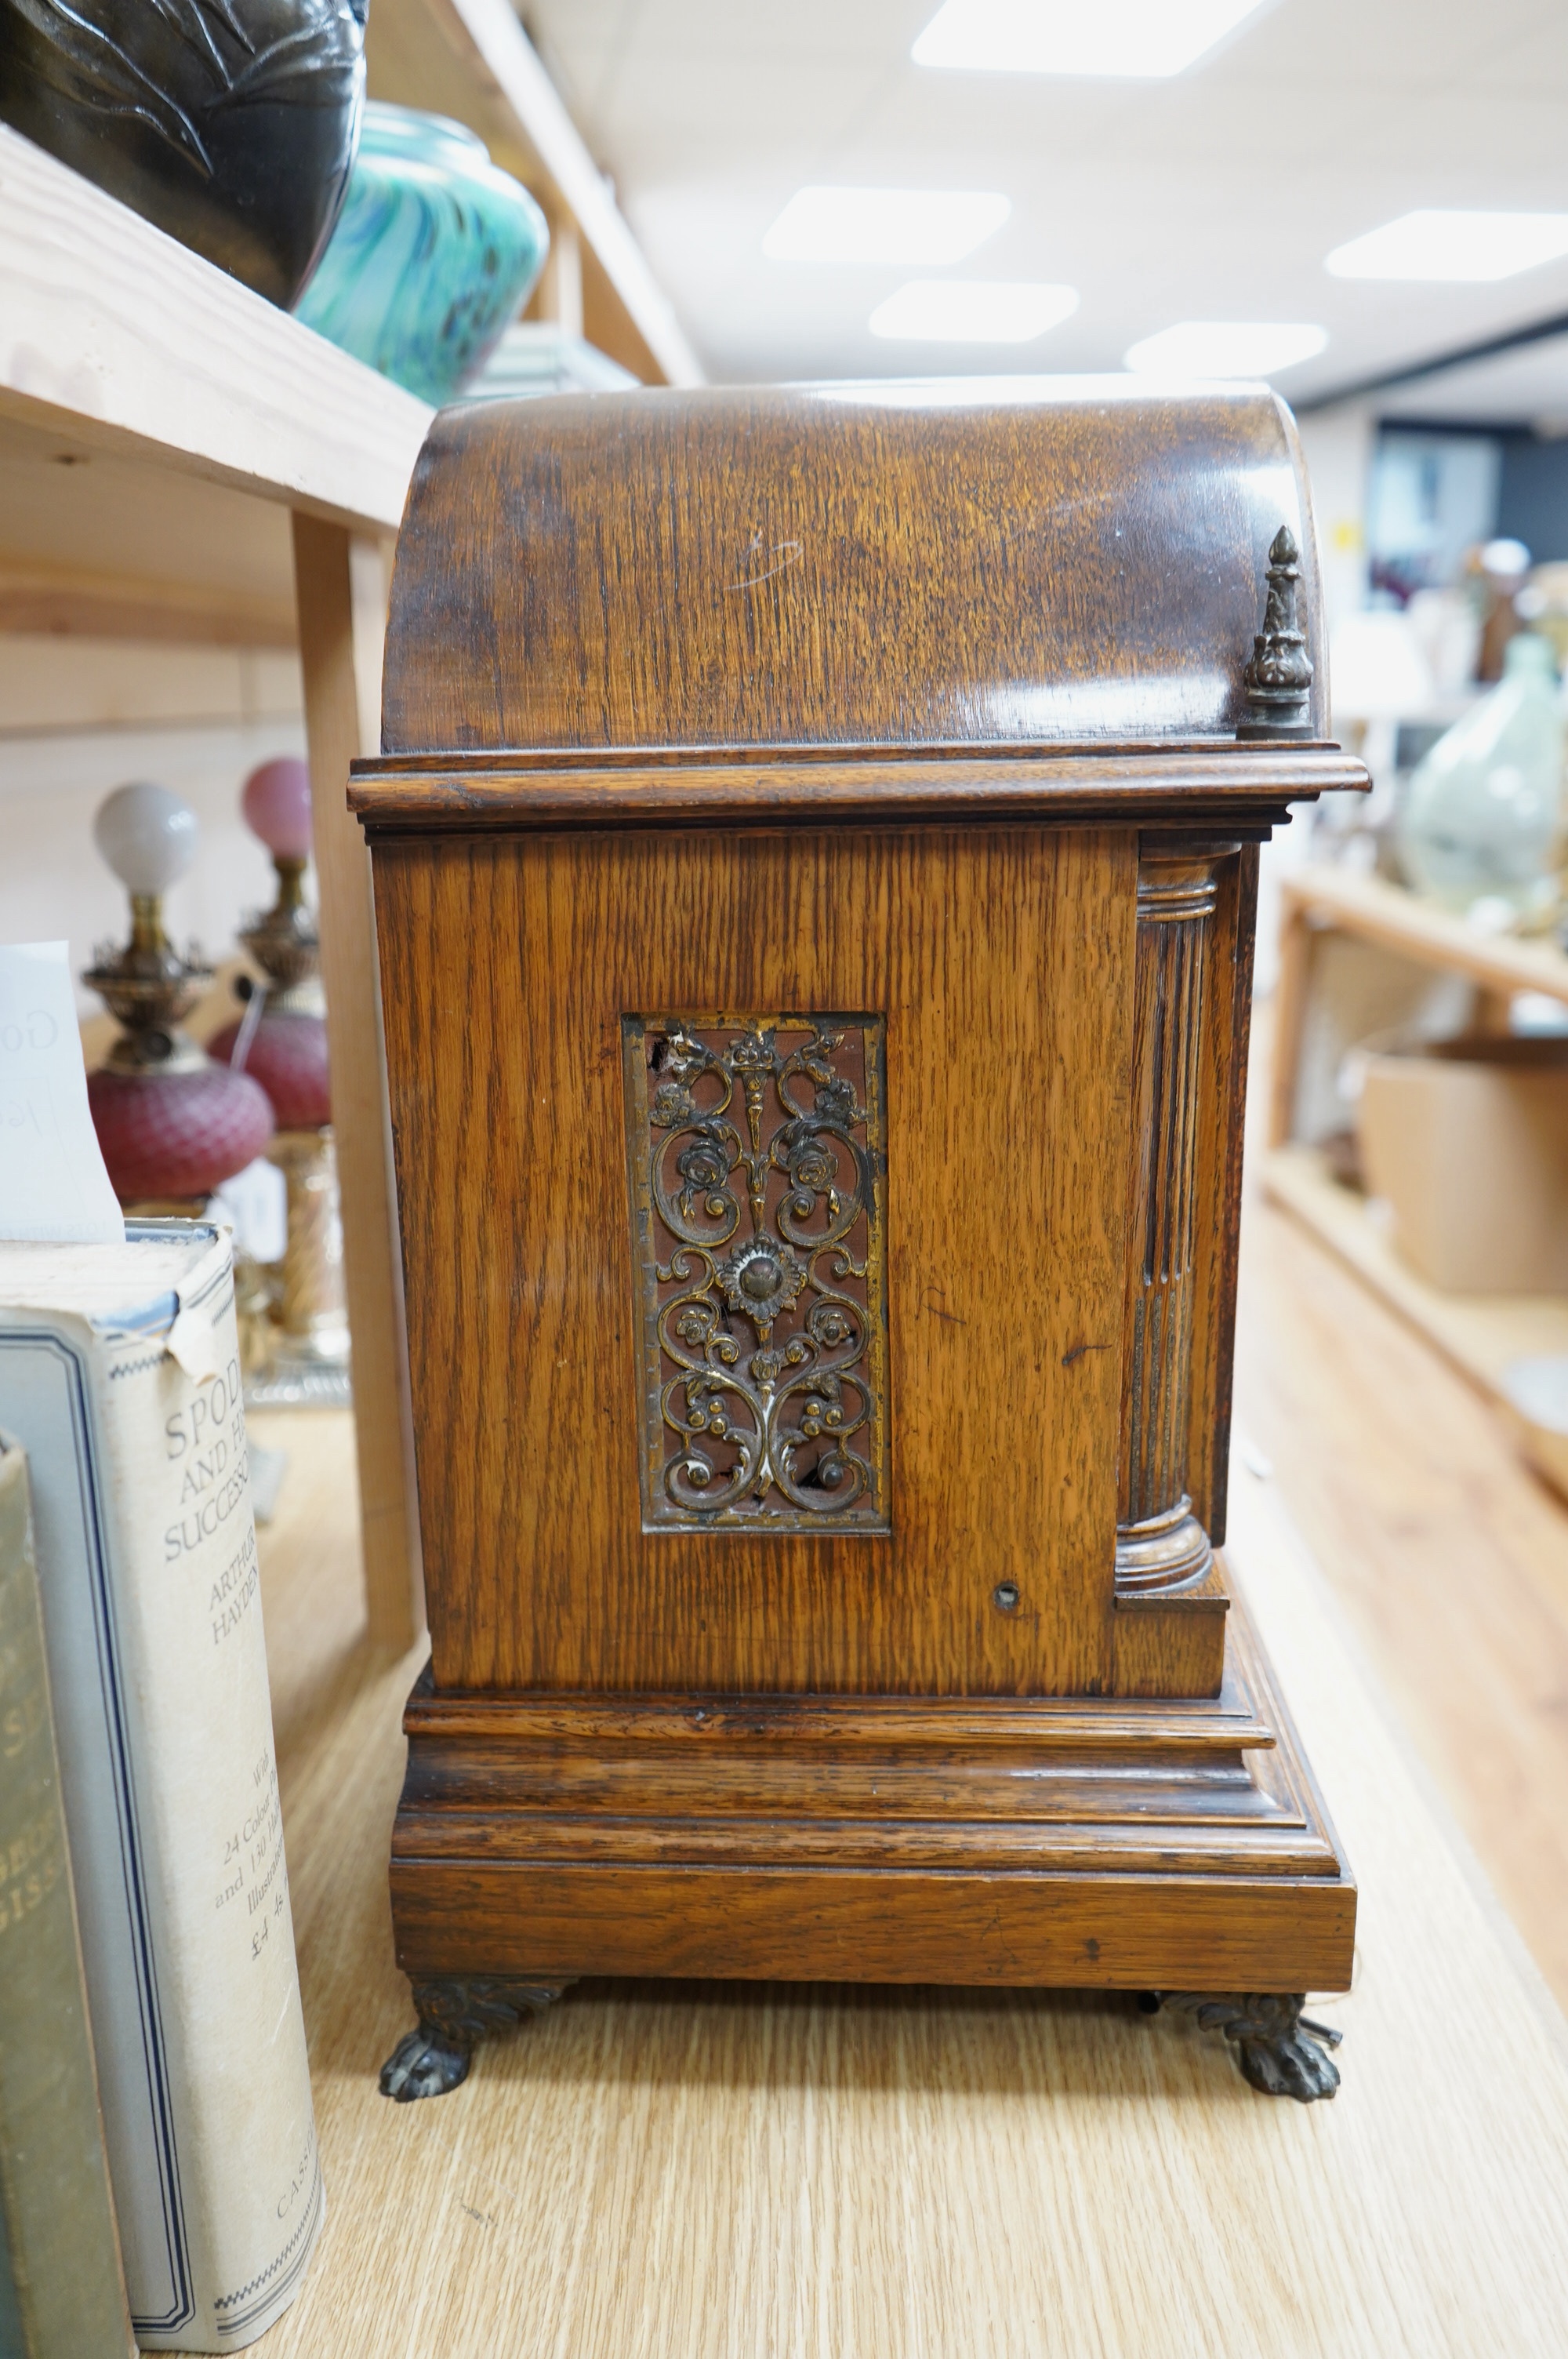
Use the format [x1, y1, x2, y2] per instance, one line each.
[1116, 852, 1217, 1594]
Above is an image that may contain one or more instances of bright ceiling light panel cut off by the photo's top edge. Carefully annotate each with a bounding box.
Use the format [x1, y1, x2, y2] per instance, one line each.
[913, 0, 1261, 80]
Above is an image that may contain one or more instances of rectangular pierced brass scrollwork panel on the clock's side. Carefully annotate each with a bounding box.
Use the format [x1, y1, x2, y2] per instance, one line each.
[622, 1014, 889, 1531]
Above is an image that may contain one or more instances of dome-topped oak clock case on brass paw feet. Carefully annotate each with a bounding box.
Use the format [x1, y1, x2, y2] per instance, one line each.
[351, 380, 1365, 2097]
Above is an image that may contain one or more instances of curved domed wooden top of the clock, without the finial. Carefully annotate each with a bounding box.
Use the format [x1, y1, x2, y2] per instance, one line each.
[382, 377, 1327, 753]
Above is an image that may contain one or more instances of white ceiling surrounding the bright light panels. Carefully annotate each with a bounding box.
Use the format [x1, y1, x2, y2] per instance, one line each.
[528, 0, 1568, 398]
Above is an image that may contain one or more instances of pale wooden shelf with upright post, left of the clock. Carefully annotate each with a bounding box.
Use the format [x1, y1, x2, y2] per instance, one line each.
[0, 127, 434, 1645]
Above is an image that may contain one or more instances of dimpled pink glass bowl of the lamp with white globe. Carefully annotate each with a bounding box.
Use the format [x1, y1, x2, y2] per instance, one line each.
[87, 1064, 274, 1203]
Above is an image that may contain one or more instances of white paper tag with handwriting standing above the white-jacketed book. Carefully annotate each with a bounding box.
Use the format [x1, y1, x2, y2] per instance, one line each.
[0, 941, 125, 1245]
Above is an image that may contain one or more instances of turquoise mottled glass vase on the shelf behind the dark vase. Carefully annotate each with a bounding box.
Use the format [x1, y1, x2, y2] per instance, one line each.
[295, 101, 550, 403]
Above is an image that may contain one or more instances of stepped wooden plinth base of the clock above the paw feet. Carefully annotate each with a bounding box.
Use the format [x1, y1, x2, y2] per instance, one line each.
[391, 1608, 1356, 1991]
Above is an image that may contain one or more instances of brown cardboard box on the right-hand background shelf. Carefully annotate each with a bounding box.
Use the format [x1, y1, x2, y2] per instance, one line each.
[1356, 1038, 1568, 1295]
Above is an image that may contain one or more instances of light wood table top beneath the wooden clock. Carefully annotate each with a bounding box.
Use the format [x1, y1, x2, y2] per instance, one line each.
[241, 1416, 1568, 2359]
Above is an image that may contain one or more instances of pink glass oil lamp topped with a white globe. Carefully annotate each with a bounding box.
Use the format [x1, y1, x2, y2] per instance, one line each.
[82, 783, 274, 1212]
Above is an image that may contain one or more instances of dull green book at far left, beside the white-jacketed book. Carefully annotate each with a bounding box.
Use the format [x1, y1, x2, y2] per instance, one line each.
[0, 1434, 134, 2359]
